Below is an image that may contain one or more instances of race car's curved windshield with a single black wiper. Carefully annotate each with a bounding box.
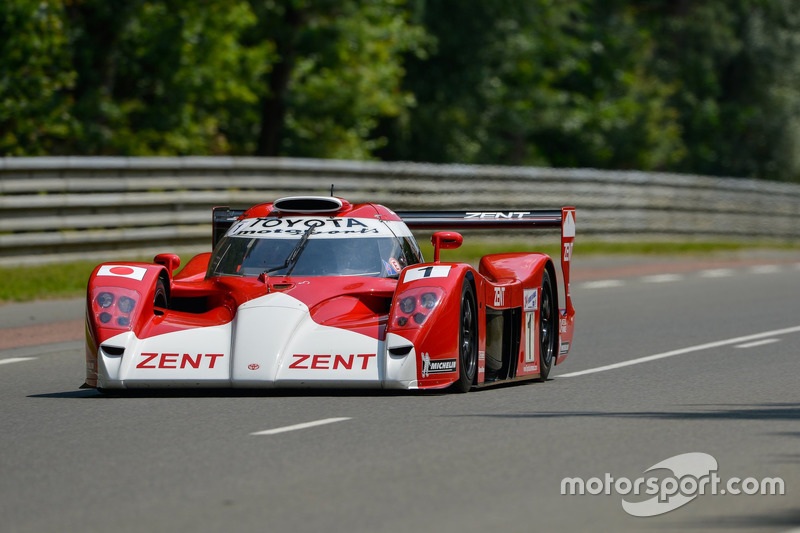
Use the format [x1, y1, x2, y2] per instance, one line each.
[207, 215, 422, 277]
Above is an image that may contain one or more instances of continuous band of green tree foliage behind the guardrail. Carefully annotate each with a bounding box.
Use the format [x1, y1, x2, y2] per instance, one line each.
[0, 0, 800, 181]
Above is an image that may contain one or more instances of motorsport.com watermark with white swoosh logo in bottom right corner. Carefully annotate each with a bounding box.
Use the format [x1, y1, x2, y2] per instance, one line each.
[561, 452, 786, 516]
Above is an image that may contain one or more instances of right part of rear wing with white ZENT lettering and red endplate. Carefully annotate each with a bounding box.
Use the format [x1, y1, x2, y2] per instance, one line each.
[397, 207, 575, 362]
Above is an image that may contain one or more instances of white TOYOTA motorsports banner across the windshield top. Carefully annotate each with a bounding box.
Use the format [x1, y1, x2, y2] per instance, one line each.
[228, 217, 391, 239]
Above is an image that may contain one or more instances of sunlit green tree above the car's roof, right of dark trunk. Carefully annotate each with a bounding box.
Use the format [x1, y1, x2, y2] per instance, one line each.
[251, 0, 426, 159]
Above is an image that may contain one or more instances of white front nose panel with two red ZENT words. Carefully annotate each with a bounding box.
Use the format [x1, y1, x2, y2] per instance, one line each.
[98, 293, 417, 389]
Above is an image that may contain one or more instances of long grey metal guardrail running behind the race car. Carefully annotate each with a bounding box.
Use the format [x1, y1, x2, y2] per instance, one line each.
[0, 157, 800, 266]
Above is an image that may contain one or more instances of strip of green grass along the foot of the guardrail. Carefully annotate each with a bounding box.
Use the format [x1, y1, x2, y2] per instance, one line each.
[0, 238, 800, 303]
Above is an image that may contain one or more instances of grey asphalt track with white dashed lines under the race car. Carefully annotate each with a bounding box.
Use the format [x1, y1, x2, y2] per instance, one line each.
[0, 254, 800, 533]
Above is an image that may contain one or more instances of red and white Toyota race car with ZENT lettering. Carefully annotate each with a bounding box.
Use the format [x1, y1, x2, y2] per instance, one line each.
[84, 196, 575, 392]
